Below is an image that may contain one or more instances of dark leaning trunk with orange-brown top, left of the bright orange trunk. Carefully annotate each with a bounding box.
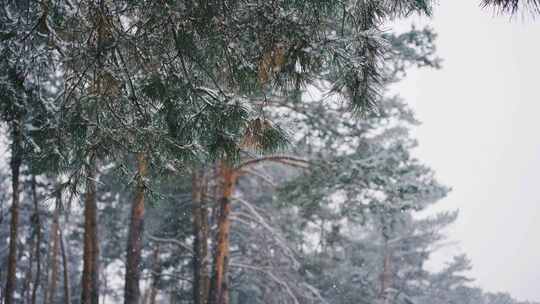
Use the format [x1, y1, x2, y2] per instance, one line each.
[124, 152, 148, 304]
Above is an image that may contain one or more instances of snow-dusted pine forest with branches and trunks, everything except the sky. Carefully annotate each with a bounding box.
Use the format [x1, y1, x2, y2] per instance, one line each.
[0, 0, 538, 304]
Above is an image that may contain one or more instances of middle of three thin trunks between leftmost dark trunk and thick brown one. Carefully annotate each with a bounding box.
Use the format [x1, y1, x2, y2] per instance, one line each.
[44, 195, 61, 304]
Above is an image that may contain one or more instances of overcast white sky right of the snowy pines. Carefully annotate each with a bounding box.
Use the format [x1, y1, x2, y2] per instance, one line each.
[397, 0, 540, 301]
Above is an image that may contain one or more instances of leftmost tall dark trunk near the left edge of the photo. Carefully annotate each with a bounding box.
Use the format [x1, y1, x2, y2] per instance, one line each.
[5, 121, 23, 304]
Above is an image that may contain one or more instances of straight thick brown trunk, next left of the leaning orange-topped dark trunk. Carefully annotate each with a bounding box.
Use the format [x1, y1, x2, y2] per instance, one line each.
[81, 156, 99, 304]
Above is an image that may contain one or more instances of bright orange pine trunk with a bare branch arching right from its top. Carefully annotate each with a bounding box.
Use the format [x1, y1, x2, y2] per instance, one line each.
[210, 162, 236, 304]
